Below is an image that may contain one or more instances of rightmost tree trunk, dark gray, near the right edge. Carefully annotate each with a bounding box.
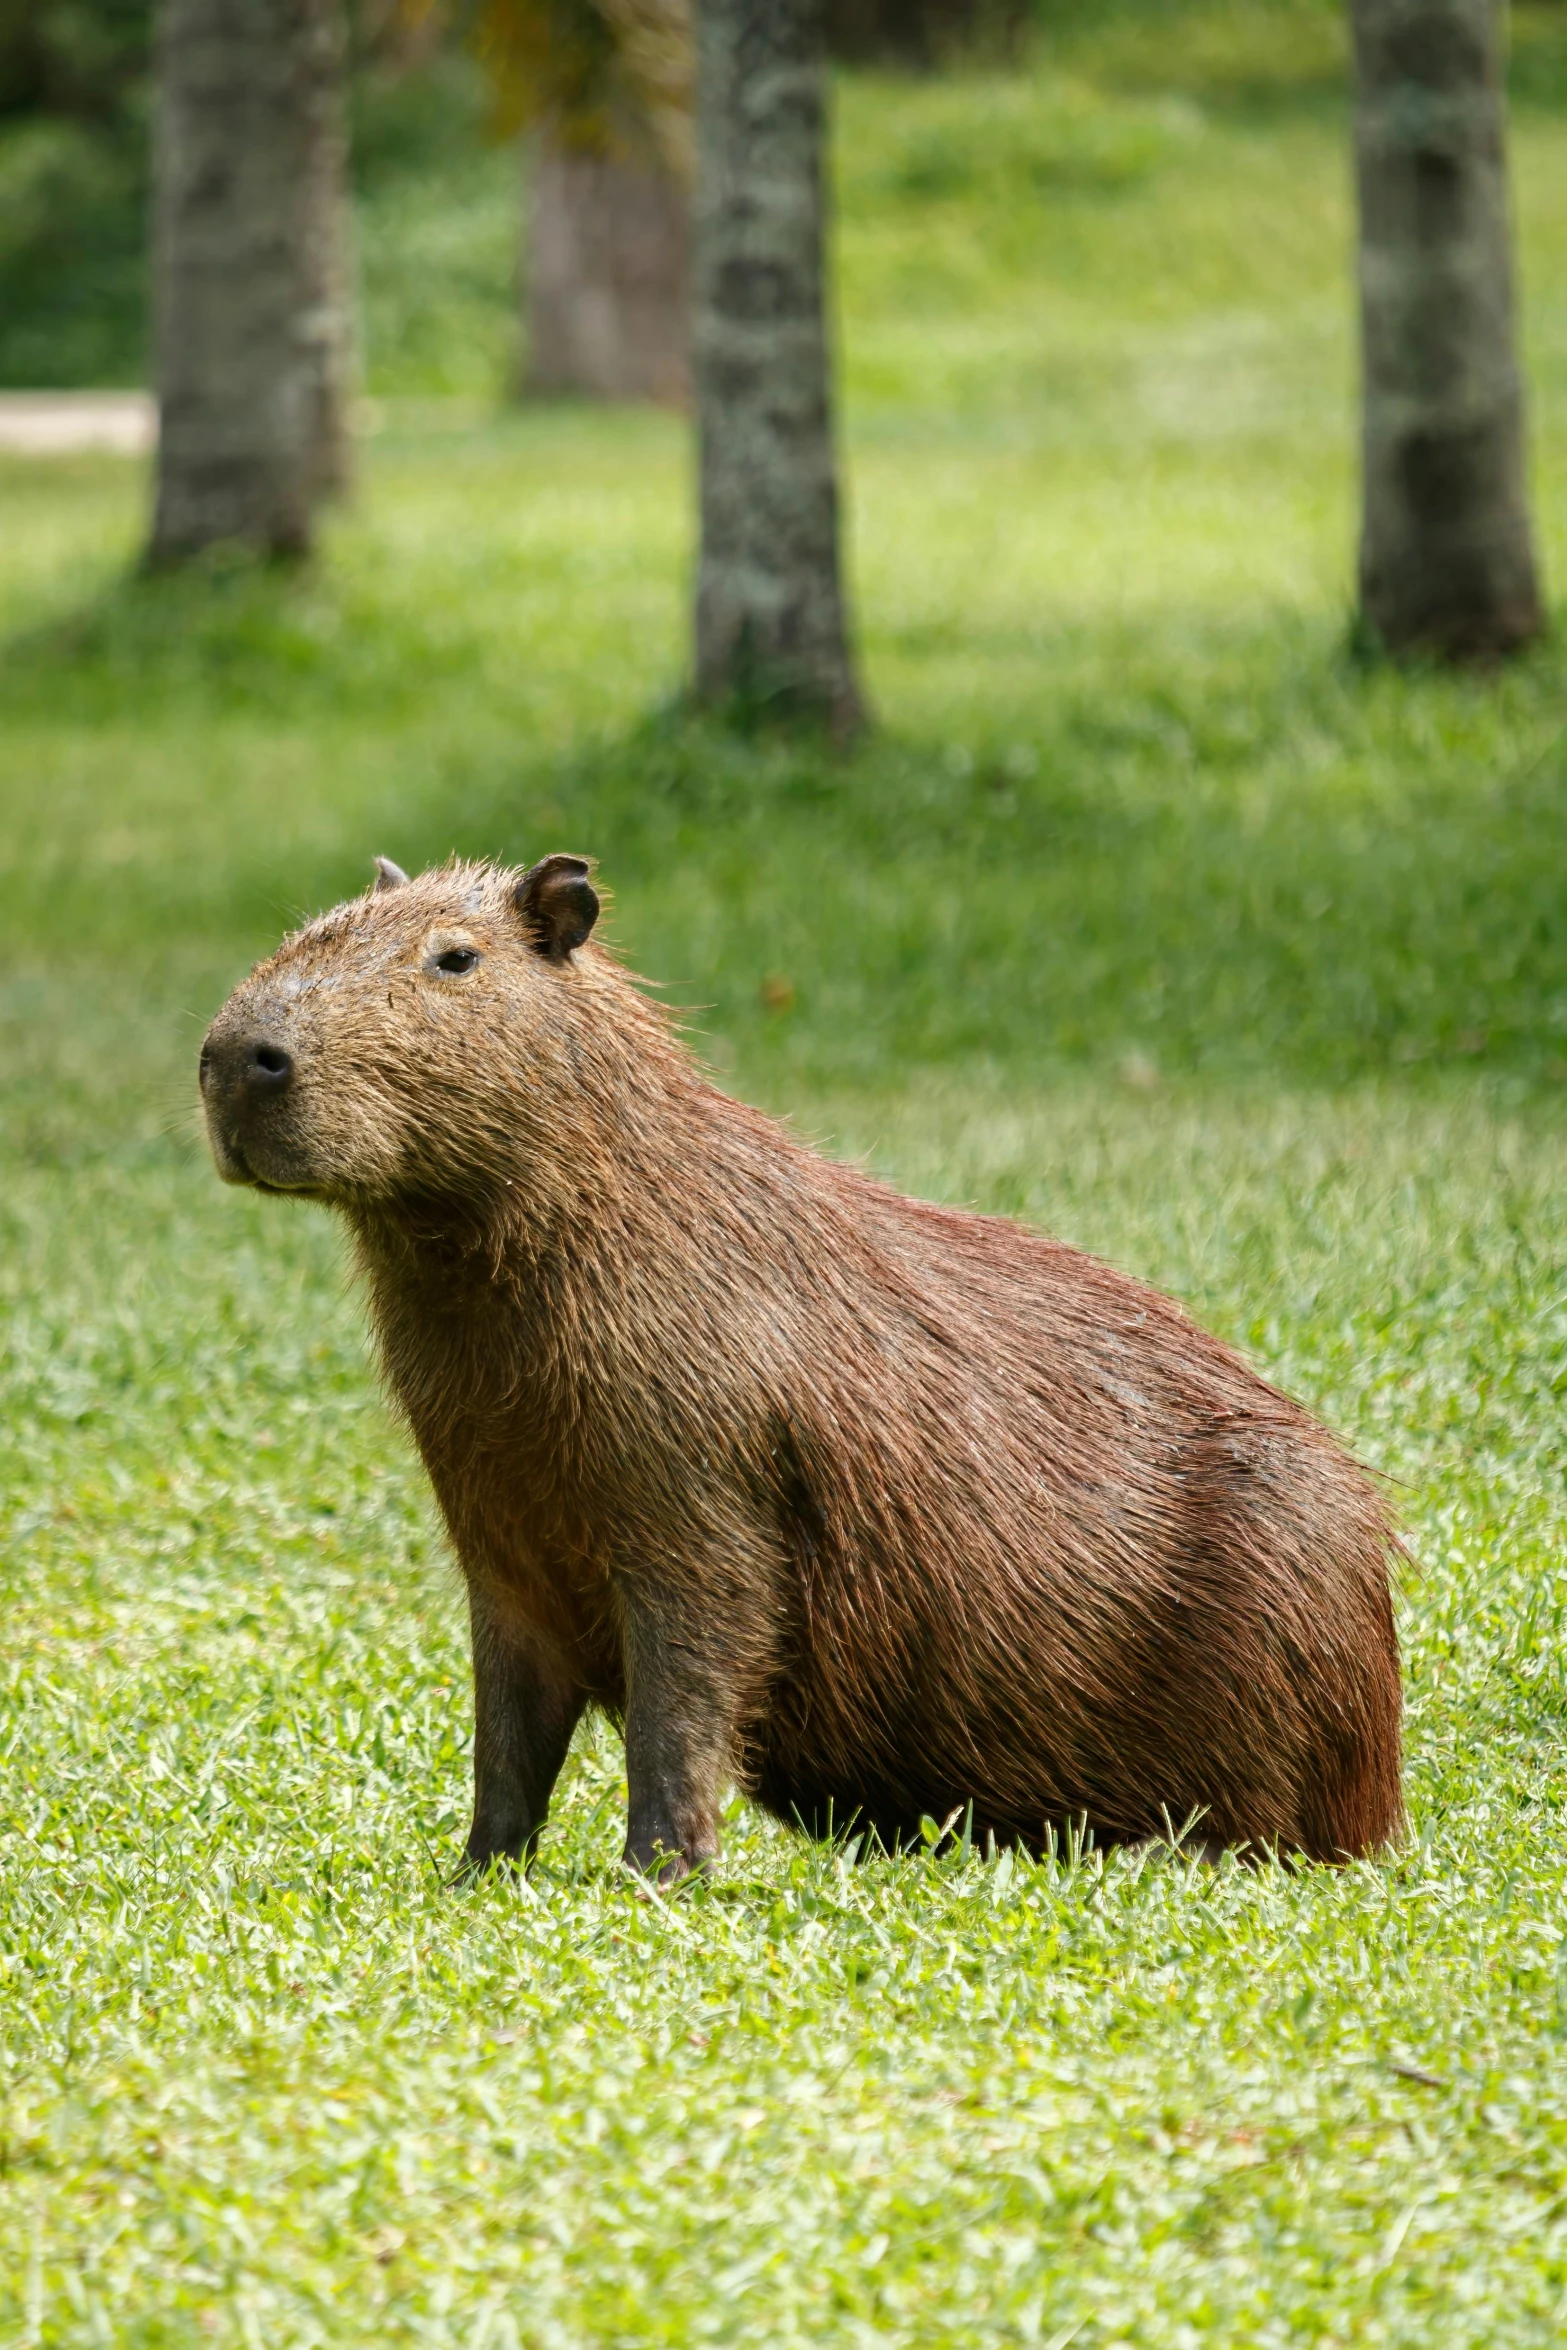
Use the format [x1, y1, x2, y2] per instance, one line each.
[1351, 0, 1541, 660]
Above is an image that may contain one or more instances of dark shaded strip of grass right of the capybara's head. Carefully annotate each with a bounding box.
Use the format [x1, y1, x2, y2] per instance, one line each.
[521, 663, 1567, 1083]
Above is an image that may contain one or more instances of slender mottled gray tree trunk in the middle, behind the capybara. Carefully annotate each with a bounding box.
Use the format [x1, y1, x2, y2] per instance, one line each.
[695, 0, 862, 733]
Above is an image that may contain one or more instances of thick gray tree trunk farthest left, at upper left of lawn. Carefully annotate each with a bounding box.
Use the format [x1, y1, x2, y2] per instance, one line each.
[150, 0, 352, 564]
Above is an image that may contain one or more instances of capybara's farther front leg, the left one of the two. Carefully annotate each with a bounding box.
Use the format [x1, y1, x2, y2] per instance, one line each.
[463, 1584, 583, 1875]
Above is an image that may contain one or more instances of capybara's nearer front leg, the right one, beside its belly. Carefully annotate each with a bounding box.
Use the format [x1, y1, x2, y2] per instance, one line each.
[620, 1577, 745, 1885]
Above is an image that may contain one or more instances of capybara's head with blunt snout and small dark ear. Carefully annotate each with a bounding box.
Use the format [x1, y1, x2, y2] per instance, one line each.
[202, 855, 599, 1208]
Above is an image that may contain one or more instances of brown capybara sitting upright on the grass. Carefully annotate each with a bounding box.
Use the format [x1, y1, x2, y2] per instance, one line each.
[202, 855, 1400, 1878]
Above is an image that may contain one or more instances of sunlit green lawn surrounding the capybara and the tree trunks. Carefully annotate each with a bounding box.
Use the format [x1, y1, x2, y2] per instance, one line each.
[0, 0, 1567, 2350]
